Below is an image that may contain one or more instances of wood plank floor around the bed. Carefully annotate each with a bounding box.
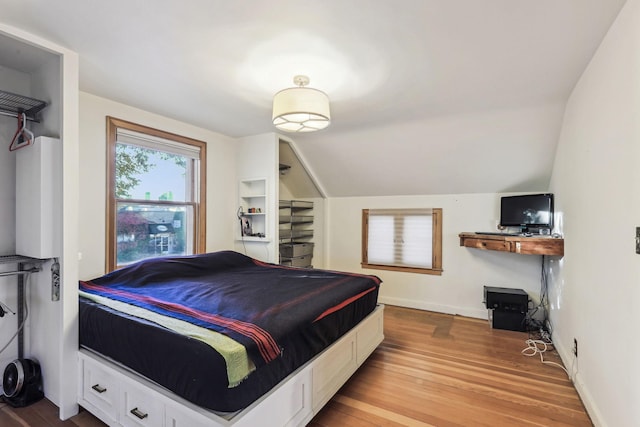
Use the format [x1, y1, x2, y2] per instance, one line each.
[0, 306, 592, 427]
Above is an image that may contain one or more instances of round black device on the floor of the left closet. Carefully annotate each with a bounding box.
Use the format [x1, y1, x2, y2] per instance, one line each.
[2, 359, 44, 408]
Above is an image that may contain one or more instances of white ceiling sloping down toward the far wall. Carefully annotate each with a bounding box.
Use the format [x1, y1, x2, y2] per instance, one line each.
[0, 0, 625, 196]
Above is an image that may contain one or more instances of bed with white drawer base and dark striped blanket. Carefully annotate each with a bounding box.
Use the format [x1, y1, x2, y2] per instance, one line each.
[78, 251, 383, 426]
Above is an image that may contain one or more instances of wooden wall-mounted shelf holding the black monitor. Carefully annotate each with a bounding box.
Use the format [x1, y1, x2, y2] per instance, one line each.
[459, 233, 564, 256]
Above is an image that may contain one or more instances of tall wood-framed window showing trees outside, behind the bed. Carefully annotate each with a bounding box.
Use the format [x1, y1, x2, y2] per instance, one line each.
[106, 117, 206, 271]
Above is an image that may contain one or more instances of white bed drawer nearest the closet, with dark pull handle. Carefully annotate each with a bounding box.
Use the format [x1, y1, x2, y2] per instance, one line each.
[79, 358, 120, 422]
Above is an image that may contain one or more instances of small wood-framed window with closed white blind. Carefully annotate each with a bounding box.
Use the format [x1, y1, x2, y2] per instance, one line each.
[362, 209, 442, 275]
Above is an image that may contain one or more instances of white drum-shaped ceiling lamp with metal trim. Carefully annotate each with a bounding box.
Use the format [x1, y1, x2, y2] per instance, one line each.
[273, 76, 331, 132]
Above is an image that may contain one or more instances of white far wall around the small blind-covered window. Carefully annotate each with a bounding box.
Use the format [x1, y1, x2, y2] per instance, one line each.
[325, 194, 557, 318]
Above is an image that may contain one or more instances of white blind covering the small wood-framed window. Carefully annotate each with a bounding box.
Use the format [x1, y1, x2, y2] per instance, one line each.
[367, 209, 433, 268]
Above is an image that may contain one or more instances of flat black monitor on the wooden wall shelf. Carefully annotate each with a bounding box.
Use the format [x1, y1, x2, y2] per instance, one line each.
[500, 193, 553, 233]
